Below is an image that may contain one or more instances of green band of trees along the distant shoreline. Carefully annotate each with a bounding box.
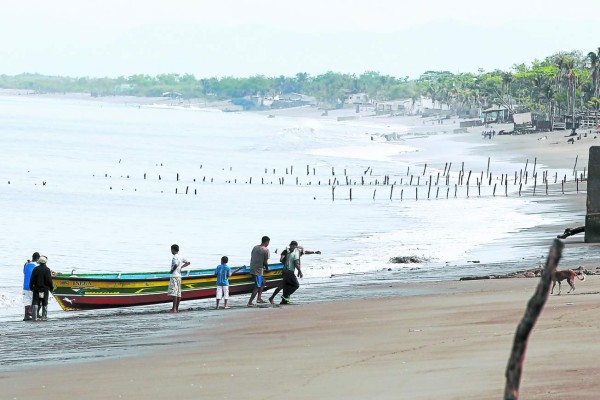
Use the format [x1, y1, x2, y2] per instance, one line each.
[0, 47, 600, 118]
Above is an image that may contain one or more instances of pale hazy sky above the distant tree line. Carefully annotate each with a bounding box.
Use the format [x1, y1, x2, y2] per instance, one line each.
[0, 0, 600, 78]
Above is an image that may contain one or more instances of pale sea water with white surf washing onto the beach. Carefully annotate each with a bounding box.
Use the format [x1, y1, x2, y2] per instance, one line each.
[0, 95, 584, 369]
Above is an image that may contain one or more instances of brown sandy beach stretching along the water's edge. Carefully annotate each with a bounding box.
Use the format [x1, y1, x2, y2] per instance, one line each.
[0, 97, 600, 399]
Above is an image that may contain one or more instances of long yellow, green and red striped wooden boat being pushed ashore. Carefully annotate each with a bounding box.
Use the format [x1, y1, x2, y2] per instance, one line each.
[52, 263, 283, 311]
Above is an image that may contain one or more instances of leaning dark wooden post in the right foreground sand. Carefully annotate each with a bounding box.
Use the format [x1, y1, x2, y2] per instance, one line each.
[504, 239, 564, 400]
